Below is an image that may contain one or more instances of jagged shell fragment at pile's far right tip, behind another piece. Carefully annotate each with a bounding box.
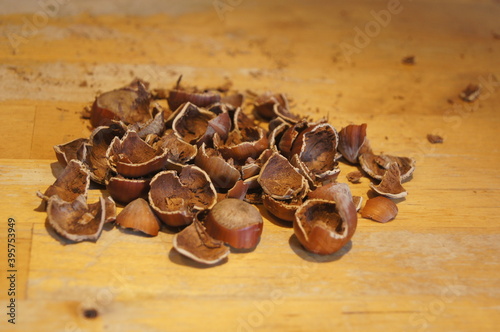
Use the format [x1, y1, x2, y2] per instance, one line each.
[359, 152, 416, 181]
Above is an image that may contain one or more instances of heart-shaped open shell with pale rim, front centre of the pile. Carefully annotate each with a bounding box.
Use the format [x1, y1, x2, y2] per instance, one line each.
[148, 165, 217, 227]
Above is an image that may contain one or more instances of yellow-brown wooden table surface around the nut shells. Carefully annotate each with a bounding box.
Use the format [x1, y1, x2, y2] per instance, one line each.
[0, 0, 500, 331]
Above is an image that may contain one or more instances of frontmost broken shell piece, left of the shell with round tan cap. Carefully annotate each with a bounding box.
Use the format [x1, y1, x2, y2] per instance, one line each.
[172, 219, 230, 265]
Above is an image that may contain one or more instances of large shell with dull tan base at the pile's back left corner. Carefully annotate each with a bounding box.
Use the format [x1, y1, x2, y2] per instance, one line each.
[90, 82, 151, 127]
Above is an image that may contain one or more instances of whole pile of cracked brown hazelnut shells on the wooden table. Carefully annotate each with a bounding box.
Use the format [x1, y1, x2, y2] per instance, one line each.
[37, 78, 415, 265]
